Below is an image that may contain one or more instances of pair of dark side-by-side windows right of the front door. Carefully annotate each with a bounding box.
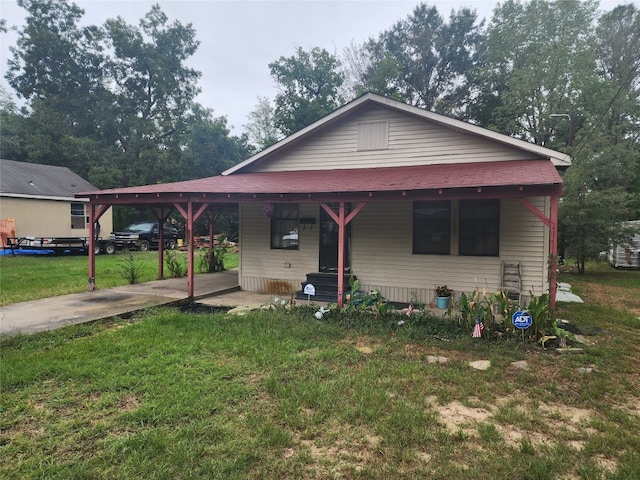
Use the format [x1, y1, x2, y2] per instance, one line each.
[413, 200, 500, 256]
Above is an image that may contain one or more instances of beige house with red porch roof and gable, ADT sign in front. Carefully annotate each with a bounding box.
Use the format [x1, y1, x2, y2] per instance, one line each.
[82, 93, 570, 303]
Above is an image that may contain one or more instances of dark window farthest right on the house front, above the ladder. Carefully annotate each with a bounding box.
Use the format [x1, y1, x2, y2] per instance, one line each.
[458, 200, 500, 257]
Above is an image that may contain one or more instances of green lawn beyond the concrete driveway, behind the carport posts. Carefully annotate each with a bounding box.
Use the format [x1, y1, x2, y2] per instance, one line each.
[0, 251, 238, 305]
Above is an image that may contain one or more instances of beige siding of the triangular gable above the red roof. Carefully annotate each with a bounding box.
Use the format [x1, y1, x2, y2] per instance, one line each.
[251, 106, 535, 172]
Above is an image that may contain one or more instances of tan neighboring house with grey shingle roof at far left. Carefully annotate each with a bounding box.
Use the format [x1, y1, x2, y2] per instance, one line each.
[0, 160, 112, 237]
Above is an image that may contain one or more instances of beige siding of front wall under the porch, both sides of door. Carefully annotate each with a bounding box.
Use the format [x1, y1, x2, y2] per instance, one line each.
[240, 198, 549, 303]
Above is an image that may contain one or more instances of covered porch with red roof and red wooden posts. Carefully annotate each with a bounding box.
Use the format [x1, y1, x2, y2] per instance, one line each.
[81, 160, 562, 306]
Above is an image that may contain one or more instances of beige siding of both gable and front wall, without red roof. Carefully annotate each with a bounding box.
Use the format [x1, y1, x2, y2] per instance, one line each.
[226, 95, 569, 302]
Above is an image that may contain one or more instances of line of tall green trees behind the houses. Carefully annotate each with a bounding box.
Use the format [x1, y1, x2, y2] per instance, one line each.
[0, 0, 640, 270]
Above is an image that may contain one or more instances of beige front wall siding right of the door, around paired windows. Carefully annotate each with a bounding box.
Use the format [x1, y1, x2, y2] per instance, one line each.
[352, 199, 546, 303]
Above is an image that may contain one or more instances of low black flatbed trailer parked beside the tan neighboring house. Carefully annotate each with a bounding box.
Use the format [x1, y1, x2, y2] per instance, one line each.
[4, 237, 116, 257]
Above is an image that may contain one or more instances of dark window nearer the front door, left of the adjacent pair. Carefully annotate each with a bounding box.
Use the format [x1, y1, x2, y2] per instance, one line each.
[413, 200, 451, 255]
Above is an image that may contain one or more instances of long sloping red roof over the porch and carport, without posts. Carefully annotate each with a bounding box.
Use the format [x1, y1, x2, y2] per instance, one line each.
[90, 160, 562, 195]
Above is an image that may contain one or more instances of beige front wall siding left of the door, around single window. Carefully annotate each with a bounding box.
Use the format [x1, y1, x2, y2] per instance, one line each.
[239, 204, 319, 294]
